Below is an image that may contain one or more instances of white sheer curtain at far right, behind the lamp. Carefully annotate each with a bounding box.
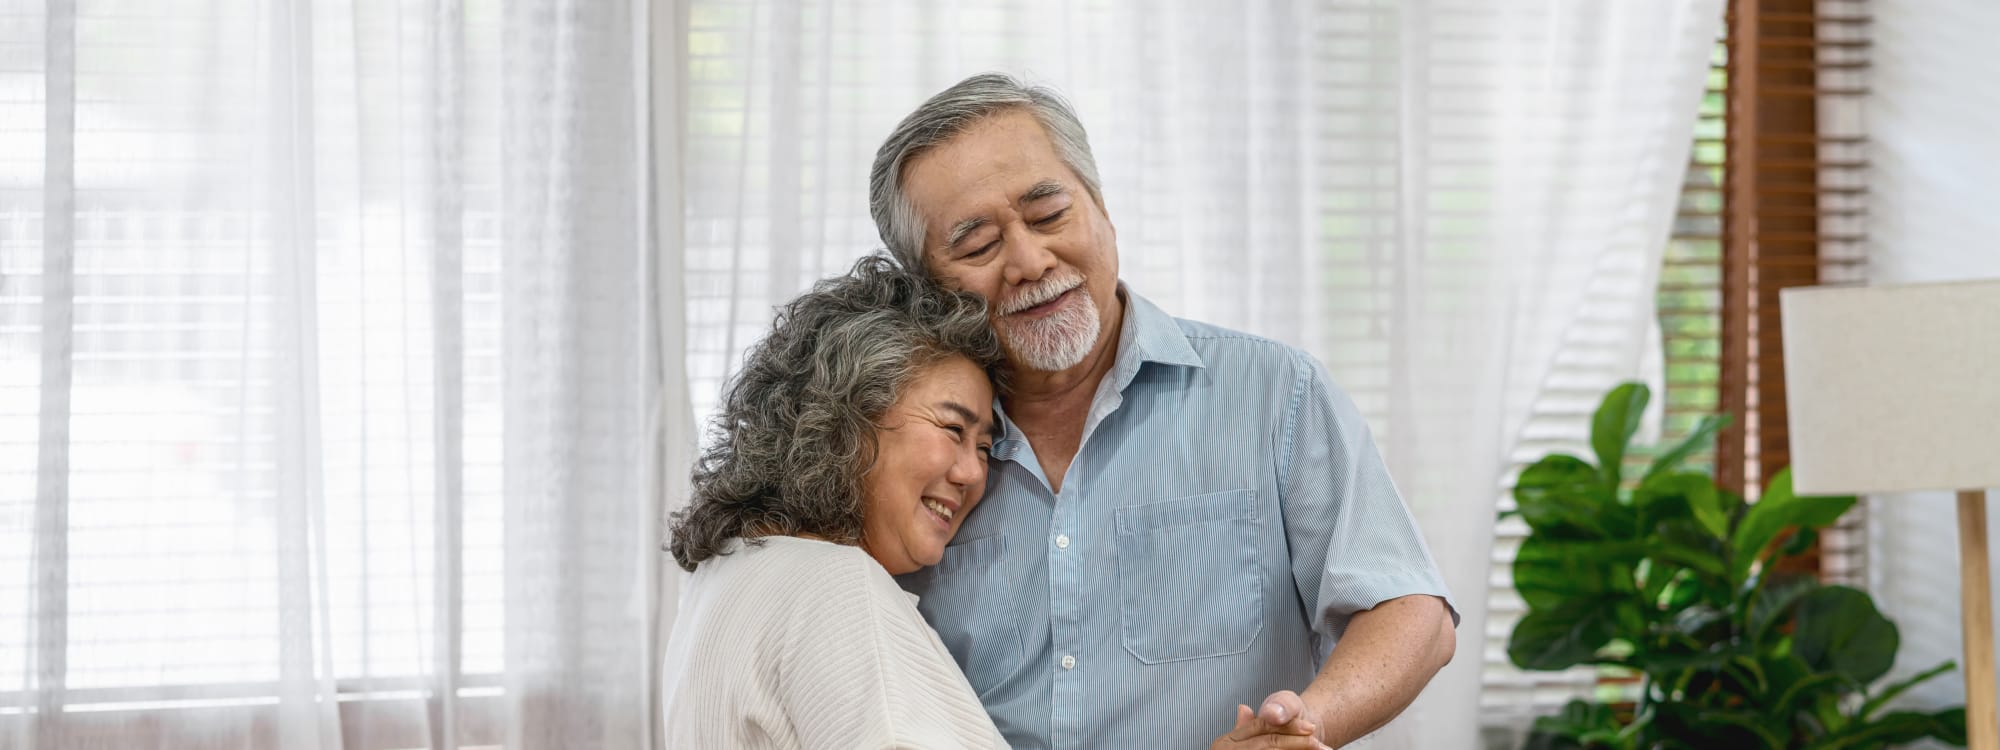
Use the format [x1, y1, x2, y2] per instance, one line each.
[1864, 0, 2000, 728]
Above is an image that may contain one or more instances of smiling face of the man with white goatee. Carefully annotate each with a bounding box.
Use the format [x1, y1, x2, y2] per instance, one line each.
[902, 112, 1118, 372]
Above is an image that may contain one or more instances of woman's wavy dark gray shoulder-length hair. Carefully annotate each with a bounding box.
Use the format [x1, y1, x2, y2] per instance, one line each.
[668, 256, 1006, 570]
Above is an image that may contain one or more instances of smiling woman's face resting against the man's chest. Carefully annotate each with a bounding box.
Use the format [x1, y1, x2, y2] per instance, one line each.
[862, 358, 994, 576]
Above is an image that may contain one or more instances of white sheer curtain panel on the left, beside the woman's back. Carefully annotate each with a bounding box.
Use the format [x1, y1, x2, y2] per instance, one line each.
[0, 0, 686, 750]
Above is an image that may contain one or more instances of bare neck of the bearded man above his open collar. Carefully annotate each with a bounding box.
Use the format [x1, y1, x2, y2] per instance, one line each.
[1002, 296, 1130, 492]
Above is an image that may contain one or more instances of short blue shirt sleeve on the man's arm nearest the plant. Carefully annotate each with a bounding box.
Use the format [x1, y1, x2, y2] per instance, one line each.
[1280, 352, 1458, 640]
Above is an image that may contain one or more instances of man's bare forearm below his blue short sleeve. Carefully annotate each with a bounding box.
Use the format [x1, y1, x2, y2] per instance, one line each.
[1300, 596, 1458, 748]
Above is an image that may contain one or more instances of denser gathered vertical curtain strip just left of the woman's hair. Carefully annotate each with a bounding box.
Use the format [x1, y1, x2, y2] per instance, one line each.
[500, 0, 660, 748]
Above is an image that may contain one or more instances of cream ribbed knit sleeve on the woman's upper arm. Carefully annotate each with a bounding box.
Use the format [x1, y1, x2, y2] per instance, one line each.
[780, 558, 1004, 748]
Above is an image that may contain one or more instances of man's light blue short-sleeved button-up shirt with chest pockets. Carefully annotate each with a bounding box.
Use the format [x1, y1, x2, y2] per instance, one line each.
[898, 286, 1458, 748]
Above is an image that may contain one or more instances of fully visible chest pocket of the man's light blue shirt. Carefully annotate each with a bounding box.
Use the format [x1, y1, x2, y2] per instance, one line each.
[1116, 490, 1264, 664]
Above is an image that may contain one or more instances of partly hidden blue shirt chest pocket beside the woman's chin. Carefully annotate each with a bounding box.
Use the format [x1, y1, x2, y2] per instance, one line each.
[914, 534, 1022, 696]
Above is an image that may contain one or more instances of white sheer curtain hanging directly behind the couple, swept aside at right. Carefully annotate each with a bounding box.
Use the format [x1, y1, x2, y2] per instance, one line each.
[684, 0, 1722, 748]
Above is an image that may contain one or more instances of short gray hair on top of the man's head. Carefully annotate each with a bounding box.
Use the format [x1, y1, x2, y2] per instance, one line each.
[868, 72, 1104, 272]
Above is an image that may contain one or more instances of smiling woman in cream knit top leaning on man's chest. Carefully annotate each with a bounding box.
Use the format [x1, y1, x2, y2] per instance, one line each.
[664, 258, 1004, 748]
